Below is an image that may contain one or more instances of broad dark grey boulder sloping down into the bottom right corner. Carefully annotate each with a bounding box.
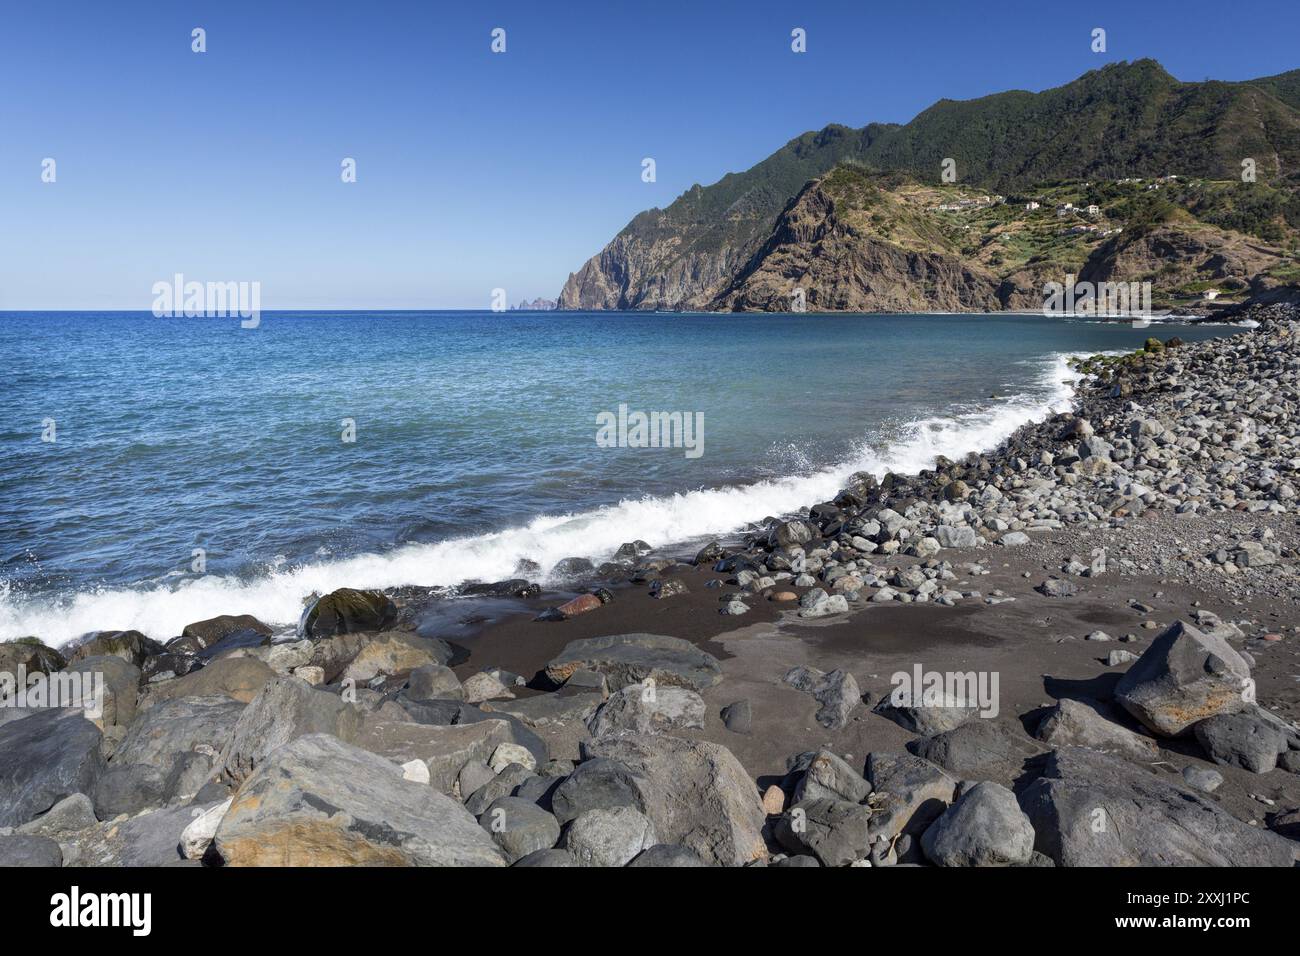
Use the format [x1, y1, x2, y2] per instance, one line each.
[1021, 747, 1296, 866]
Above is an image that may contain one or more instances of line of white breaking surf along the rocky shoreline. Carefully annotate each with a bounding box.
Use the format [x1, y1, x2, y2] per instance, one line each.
[4, 325, 1138, 645]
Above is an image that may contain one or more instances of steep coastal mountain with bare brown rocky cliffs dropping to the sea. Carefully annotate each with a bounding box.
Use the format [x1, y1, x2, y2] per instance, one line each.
[558, 60, 1300, 311]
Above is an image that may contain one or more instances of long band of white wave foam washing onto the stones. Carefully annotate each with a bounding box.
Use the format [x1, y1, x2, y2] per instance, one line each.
[0, 354, 1078, 645]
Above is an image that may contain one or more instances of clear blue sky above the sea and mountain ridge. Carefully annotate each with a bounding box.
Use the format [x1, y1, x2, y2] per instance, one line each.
[0, 0, 1300, 311]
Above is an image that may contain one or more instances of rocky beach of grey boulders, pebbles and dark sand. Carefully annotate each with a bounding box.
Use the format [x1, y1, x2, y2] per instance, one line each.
[0, 304, 1300, 866]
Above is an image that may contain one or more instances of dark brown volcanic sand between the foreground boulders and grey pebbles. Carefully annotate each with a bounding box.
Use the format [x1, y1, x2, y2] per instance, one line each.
[421, 518, 1300, 822]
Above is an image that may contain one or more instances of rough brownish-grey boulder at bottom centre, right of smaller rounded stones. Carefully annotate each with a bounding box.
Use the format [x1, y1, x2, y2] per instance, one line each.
[582, 734, 767, 866]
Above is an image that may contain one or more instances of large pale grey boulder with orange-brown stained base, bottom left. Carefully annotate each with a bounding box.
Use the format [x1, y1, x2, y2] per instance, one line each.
[213, 734, 506, 866]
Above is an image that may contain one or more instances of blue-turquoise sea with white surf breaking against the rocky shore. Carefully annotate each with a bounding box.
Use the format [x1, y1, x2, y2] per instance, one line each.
[0, 312, 1229, 641]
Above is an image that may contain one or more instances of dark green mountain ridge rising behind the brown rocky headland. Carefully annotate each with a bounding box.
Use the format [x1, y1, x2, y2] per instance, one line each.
[559, 60, 1300, 310]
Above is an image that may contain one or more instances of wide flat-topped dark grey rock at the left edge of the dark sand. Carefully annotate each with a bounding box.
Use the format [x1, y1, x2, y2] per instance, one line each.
[546, 633, 723, 697]
